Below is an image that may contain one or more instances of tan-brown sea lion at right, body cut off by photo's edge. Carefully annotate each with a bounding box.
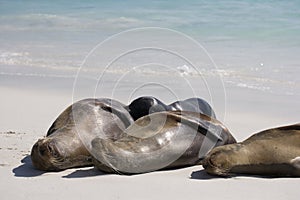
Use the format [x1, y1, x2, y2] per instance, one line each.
[202, 124, 300, 177]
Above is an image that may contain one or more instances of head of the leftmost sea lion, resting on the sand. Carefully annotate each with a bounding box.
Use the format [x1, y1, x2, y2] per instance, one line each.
[31, 129, 92, 171]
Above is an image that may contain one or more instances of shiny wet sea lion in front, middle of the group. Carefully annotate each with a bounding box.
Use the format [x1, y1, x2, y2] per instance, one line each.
[91, 111, 236, 174]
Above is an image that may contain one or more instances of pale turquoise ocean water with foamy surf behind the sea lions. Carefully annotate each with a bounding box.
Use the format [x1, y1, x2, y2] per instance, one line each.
[0, 0, 300, 98]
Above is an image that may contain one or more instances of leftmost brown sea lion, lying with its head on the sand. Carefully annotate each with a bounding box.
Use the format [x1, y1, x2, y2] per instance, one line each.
[31, 99, 133, 171]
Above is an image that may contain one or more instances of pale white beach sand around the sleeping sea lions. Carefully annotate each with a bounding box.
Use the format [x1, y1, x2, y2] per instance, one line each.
[0, 79, 300, 200]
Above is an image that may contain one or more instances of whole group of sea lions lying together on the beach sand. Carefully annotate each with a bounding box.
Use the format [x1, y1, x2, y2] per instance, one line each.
[31, 97, 300, 177]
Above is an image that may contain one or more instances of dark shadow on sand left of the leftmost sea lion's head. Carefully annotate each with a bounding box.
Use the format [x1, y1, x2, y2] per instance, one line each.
[12, 156, 45, 177]
